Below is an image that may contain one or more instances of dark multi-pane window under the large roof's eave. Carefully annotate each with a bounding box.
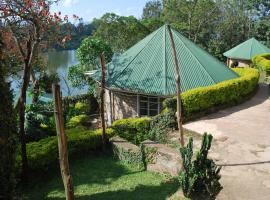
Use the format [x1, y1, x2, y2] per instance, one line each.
[138, 96, 163, 116]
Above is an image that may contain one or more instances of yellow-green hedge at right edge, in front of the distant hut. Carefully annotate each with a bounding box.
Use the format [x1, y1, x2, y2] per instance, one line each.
[252, 53, 270, 74]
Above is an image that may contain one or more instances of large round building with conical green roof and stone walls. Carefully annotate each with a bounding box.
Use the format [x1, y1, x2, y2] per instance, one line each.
[86, 25, 238, 124]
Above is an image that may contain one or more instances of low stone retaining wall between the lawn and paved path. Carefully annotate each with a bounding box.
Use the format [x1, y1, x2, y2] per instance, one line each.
[111, 137, 182, 176]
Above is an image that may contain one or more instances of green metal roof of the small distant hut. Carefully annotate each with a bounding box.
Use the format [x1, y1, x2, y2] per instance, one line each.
[223, 38, 270, 60]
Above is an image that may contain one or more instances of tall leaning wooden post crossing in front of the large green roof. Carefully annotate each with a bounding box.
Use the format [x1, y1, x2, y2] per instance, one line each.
[168, 25, 185, 147]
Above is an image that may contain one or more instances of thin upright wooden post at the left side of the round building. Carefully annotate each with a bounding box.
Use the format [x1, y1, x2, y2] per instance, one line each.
[100, 53, 106, 151]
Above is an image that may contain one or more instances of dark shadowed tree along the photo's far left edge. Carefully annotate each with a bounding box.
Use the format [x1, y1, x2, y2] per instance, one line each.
[0, 36, 17, 199]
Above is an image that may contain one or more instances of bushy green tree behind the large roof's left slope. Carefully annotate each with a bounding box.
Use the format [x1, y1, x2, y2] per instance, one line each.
[93, 13, 150, 53]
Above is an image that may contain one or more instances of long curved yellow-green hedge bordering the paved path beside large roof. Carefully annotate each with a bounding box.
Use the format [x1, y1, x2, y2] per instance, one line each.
[163, 68, 259, 121]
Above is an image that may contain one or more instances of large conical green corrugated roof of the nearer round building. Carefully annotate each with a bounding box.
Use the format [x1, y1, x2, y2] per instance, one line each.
[89, 25, 238, 96]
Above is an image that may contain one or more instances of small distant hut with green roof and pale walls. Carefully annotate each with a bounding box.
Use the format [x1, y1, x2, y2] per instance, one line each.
[223, 38, 270, 67]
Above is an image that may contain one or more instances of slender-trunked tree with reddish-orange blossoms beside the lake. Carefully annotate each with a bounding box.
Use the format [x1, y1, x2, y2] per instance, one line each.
[0, 0, 67, 181]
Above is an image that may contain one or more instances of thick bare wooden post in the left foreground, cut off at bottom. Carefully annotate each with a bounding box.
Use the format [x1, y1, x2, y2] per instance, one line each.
[52, 84, 74, 200]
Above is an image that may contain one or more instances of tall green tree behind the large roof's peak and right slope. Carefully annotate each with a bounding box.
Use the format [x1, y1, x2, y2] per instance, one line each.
[162, 0, 220, 47]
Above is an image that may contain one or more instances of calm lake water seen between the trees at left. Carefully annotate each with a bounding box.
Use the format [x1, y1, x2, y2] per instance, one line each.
[11, 50, 87, 102]
